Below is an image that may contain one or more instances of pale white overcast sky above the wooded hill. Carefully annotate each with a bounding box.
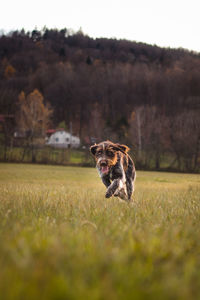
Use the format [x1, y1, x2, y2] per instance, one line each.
[0, 0, 200, 52]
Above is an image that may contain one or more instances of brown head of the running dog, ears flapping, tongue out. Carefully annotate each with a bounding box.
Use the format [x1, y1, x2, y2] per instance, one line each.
[90, 141, 129, 174]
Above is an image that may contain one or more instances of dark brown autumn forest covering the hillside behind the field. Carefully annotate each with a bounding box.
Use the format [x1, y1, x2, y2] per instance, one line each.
[0, 28, 200, 172]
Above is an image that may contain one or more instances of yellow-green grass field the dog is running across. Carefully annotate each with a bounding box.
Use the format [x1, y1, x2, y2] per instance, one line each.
[0, 164, 200, 300]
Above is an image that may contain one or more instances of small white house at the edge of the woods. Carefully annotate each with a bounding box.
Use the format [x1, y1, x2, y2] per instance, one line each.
[46, 130, 80, 148]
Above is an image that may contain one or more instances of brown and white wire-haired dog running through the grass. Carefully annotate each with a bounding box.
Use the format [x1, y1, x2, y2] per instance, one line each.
[90, 141, 136, 201]
